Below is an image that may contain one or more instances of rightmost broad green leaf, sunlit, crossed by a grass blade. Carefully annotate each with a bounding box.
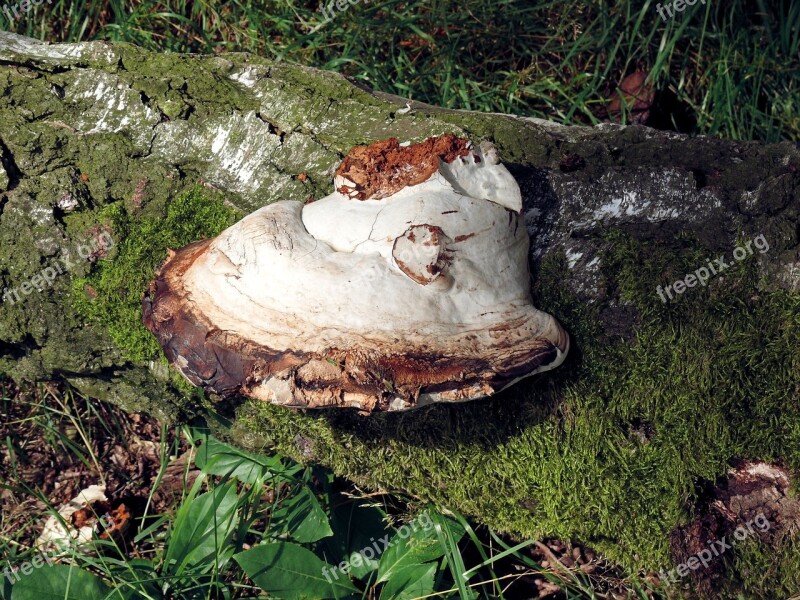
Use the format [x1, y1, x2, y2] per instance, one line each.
[378, 512, 464, 582]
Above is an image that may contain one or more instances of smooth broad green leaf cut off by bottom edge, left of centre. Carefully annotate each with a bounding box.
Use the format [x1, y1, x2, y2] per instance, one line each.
[233, 542, 360, 600]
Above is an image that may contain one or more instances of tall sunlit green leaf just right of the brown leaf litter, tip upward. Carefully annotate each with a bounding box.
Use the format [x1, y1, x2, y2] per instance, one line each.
[164, 478, 238, 576]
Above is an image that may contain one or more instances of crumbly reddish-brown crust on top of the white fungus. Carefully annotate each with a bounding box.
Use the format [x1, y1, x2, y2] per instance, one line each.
[336, 133, 469, 200]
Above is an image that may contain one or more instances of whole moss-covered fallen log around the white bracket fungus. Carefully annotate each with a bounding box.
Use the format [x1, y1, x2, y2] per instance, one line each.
[0, 33, 800, 591]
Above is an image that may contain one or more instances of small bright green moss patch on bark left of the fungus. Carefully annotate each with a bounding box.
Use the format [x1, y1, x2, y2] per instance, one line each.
[72, 188, 236, 360]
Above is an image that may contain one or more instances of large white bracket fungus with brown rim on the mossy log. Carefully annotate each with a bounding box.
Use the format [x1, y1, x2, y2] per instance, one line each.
[143, 135, 569, 411]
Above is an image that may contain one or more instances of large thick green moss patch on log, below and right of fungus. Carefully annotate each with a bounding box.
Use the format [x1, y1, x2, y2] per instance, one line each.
[227, 227, 800, 592]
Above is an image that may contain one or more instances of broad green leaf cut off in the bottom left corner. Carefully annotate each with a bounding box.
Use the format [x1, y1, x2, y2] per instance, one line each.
[11, 565, 122, 600]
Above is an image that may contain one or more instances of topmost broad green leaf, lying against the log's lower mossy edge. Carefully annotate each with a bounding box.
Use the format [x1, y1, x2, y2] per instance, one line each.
[194, 436, 298, 483]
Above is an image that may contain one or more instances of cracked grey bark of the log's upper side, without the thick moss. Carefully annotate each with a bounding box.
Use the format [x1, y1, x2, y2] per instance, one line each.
[0, 32, 800, 416]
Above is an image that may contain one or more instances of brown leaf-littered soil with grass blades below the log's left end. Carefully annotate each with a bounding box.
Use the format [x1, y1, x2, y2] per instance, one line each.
[0, 380, 197, 547]
